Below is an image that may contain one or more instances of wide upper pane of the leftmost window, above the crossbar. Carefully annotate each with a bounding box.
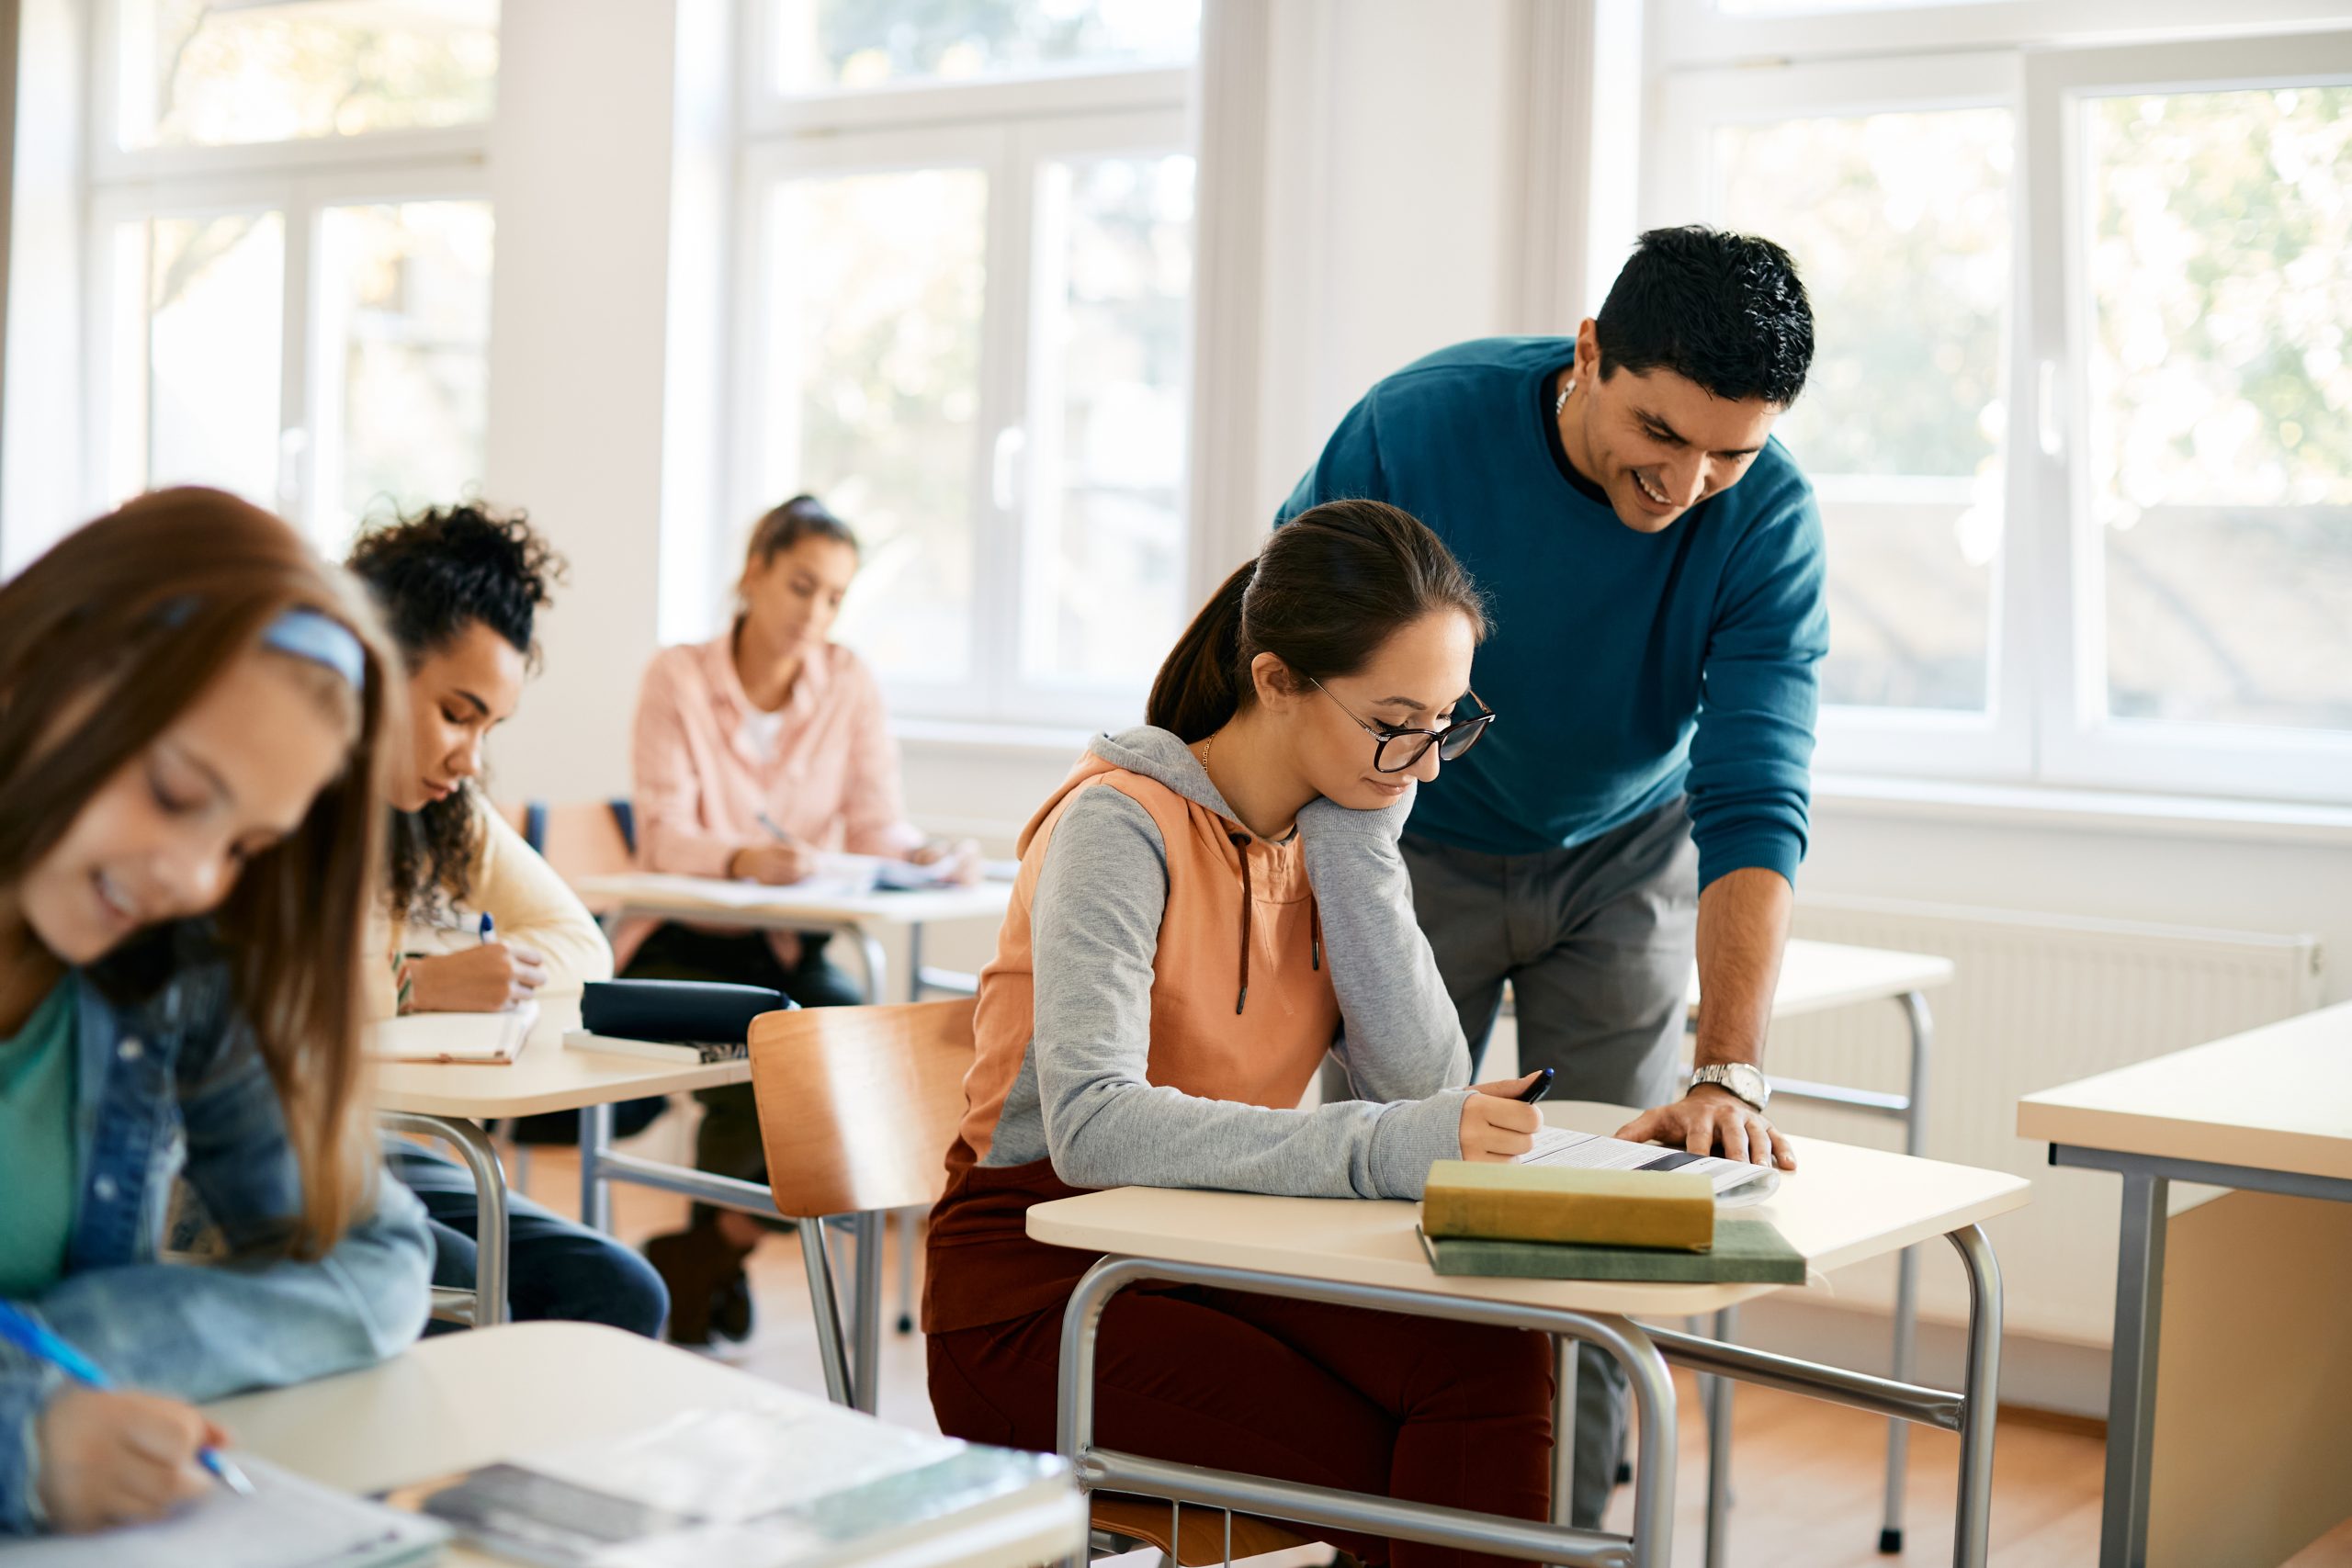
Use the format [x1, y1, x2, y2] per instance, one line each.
[118, 0, 499, 148]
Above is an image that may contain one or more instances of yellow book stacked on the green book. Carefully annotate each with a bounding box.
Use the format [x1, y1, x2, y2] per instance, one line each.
[1420, 1159, 1714, 1253]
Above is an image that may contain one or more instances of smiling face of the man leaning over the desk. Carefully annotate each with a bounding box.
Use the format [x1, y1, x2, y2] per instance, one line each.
[1553, 320, 1782, 534]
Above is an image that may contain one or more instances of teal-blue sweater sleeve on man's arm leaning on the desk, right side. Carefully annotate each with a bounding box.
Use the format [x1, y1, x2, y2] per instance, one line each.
[1689, 479, 1830, 888]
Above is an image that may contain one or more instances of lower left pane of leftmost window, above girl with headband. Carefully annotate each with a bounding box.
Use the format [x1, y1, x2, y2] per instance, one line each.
[108, 211, 285, 508]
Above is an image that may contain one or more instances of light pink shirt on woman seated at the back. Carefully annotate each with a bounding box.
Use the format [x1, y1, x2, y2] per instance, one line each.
[614, 627, 922, 966]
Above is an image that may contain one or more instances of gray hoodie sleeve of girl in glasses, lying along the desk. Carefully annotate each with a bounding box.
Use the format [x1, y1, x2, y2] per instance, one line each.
[1030, 787, 1461, 1199]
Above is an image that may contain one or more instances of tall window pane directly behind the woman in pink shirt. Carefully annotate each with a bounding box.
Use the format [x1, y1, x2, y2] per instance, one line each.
[760, 169, 988, 682]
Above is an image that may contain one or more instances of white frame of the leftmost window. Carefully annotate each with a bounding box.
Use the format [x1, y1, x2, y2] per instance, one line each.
[80, 0, 496, 555]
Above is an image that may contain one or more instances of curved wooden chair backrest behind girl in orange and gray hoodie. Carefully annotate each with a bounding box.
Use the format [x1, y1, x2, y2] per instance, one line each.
[751, 997, 974, 1220]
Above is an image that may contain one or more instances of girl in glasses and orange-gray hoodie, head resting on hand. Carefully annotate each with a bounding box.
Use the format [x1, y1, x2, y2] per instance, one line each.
[924, 501, 1553, 1563]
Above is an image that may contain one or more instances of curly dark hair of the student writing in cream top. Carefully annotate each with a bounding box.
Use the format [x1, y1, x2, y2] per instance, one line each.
[348, 501, 564, 917]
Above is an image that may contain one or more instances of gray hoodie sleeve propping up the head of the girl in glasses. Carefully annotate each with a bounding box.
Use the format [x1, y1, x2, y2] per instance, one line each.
[1298, 790, 1470, 1100]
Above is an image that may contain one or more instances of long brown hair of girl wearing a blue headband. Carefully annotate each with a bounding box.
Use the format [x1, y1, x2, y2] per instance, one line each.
[0, 489, 400, 1256]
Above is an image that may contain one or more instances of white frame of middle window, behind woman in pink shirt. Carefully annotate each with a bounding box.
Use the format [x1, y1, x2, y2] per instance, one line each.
[706, 0, 1200, 727]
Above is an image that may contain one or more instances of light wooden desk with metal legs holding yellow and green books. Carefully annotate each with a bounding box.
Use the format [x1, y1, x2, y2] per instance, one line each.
[1028, 1102, 2030, 1563]
